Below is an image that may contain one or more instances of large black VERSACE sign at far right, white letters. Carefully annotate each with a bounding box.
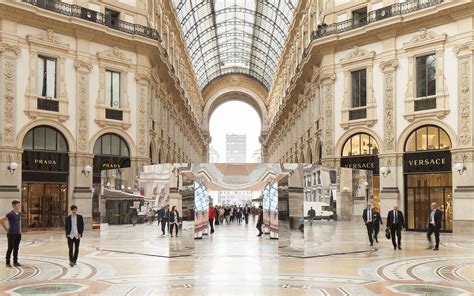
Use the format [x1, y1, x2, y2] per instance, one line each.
[403, 150, 451, 173]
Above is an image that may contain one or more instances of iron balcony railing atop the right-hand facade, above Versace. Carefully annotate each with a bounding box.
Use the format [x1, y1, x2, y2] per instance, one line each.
[311, 0, 443, 40]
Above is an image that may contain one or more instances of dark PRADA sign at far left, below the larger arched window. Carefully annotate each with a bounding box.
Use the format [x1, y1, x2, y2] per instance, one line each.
[23, 151, 69, 173]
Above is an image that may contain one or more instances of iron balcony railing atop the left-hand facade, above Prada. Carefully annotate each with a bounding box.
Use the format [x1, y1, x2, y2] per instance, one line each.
[22, 0, 162, 44]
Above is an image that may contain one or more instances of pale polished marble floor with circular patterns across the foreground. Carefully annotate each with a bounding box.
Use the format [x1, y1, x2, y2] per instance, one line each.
[0, 221, 474, 296]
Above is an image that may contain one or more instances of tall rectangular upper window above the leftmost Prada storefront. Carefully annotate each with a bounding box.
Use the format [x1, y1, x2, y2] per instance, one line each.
[36, 56, 57, 98]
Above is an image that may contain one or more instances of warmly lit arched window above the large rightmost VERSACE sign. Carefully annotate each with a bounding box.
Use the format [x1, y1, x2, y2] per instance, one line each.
[405, 125, 451, 152]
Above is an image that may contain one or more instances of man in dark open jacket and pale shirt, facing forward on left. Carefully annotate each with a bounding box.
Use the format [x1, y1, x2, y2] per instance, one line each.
[65, 205, 84, 267]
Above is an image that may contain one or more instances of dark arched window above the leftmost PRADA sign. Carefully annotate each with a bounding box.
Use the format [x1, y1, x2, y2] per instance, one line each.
[23, 125, 68, 153]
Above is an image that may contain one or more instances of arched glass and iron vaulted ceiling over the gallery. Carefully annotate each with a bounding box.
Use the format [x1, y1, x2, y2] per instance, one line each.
[173, 0, 298, 89]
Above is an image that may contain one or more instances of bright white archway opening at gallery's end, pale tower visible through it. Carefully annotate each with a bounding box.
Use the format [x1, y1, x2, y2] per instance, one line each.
[209, 101, 262, 163]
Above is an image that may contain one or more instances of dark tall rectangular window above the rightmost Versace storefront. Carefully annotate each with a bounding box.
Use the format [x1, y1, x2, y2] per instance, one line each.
[416, 54, 436, 98]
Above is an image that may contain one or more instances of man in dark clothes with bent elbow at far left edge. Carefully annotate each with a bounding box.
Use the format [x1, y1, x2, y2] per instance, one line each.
[0, 200, 21, 267]
